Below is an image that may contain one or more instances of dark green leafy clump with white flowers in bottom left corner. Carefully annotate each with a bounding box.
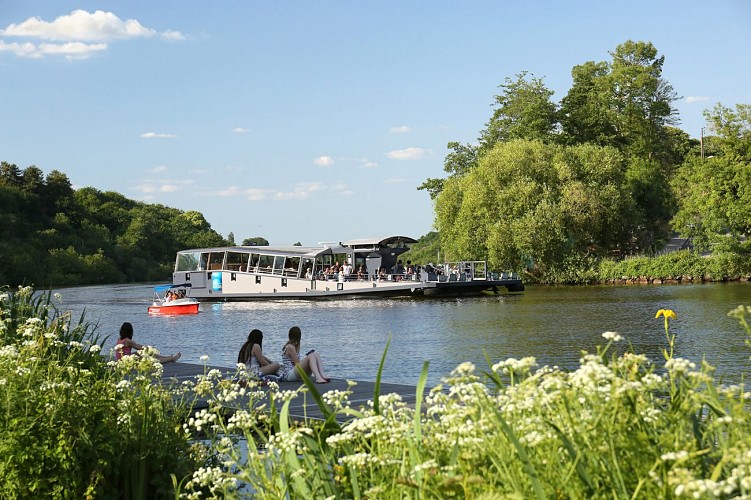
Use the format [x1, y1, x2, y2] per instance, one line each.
[0, 287, 203, 499]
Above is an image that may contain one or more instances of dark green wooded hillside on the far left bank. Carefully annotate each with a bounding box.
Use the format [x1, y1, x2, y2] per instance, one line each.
[0, 162, 227, 287]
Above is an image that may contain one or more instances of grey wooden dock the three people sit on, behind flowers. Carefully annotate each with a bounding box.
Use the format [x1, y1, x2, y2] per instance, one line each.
[162, 362, 427, 421]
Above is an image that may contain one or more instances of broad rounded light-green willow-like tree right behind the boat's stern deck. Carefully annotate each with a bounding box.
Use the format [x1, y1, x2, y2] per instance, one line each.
[436, 140, 637, 277]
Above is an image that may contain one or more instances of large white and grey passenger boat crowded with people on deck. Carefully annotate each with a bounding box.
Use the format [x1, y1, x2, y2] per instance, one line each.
[172, 236, 524, 301]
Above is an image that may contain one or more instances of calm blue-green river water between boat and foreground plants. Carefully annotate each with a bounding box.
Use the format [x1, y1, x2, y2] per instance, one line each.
[58, 283, 751, 384]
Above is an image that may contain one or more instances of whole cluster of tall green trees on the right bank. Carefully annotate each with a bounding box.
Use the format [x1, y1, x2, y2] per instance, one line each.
[418, 41, 751, 281]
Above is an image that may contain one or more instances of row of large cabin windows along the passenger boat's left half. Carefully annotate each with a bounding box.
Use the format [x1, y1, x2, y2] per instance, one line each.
[175, 252, 356, 276]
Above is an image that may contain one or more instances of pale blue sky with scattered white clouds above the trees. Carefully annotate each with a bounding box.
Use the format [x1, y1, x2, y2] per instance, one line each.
[0, 0, 751, 244]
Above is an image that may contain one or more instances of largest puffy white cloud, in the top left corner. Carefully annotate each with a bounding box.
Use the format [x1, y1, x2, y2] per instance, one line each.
[0, 10, 185, 59]
